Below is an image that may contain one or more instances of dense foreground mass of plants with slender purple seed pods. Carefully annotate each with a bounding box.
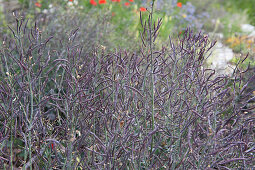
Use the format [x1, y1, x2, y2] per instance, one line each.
[0, 1, 255, 169]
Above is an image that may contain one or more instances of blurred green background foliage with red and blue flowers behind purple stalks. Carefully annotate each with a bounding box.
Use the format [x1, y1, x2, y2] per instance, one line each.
[0, 0, 254, 50]
